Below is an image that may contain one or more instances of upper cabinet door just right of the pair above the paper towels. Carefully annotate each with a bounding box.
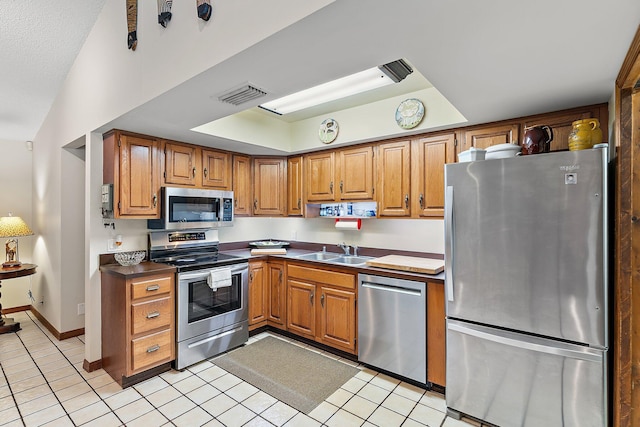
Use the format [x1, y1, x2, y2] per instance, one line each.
[376, 139, 411, 217]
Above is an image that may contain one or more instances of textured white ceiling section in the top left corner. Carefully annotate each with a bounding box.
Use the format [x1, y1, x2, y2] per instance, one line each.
[0, 0, 105, 141]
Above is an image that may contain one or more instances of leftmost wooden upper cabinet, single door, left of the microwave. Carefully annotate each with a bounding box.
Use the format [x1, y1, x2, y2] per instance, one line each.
[102, 130, 162, 219]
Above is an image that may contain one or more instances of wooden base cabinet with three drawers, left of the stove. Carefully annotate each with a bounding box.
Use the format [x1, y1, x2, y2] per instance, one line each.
[101, 263, 175, 387]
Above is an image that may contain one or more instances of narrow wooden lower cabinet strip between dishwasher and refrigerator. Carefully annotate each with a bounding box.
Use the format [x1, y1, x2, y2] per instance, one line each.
[427, 282, 447, 387]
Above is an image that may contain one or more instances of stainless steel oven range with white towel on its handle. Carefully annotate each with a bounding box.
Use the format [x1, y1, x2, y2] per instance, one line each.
[149, 229, 249, 369]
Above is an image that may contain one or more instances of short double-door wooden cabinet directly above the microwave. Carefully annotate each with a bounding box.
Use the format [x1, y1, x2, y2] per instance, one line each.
[164, 141, 231, 190]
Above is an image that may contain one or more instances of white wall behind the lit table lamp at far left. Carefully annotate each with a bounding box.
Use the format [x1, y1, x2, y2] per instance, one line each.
[0, 141, 33, 308]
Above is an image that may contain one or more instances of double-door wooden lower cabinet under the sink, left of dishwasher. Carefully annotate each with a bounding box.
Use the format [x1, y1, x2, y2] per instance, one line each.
[287, 264, 358, 354]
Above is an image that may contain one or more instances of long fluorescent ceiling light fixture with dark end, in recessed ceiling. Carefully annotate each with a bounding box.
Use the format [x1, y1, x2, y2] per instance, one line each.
[259, 60, 413, 115]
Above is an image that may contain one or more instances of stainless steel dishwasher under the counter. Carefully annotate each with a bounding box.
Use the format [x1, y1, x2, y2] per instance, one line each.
[358, 274, 427, 384]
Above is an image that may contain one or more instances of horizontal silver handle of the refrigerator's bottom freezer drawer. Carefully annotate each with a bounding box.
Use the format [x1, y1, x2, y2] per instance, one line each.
[447, 320, 604, 363]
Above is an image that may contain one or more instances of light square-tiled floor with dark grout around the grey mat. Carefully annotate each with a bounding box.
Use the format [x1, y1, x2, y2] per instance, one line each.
[0, 312, 480, 427]
